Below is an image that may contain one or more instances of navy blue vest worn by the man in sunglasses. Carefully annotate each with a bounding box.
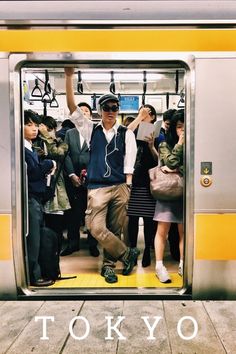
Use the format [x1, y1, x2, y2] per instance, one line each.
[88, 125, 127, 189]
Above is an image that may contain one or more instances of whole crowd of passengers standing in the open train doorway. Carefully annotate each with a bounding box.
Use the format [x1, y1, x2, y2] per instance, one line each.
[24, 68, 184, 286]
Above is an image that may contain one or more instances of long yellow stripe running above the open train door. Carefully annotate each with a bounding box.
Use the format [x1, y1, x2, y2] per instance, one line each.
[0, 29, 236, 52]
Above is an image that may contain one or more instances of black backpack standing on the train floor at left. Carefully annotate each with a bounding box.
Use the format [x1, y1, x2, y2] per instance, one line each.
[39, 226, 77, 280]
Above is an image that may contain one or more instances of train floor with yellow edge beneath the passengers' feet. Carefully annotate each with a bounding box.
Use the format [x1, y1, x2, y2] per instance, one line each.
[52, 225, 183, 288]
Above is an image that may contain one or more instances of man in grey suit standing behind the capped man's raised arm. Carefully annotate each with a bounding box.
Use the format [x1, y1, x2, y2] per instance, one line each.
[61, 102, 99, 257]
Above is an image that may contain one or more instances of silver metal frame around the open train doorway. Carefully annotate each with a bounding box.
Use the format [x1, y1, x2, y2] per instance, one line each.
[9, 52, 195, 299]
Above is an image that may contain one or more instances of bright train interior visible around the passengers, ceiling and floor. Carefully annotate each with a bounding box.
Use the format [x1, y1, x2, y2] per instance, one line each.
[20, 62, 186, 294]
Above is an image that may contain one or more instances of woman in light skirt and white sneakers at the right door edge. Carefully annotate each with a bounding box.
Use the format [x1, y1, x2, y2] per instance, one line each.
[150, 109, 184, 283]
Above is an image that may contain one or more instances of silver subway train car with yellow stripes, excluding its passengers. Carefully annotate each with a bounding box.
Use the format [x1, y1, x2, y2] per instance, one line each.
[0, 1, 236, 300]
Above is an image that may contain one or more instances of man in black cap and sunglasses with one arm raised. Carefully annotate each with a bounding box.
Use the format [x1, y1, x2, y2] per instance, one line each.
[65, 68, 139, 283]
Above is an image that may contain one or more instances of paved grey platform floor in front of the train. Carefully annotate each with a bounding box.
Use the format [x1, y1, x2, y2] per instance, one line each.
[0, 301, 236, 354]
